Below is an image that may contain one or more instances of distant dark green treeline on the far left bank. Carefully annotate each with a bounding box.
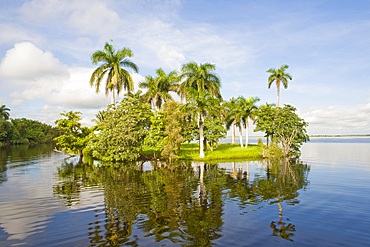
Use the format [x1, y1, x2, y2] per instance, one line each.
[0, 118, 64, 146]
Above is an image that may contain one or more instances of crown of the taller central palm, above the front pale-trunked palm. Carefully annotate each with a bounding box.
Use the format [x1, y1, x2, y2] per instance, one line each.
[178, 62, 222, 99]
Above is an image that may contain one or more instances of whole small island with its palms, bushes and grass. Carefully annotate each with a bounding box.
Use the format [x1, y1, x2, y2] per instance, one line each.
[55, 40, 309, 162]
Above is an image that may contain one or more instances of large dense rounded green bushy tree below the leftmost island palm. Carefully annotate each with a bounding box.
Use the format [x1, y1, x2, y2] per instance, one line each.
[88, 92, 153, 161]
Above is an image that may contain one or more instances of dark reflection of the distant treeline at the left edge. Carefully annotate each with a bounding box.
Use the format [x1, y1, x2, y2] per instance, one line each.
[0, 143, 54, 185]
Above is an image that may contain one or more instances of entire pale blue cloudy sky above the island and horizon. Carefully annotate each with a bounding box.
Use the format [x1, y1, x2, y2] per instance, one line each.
[0, 0, 370, 135]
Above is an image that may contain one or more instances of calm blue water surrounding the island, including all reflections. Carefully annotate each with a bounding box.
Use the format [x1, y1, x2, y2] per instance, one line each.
[0, 138, 370, 246]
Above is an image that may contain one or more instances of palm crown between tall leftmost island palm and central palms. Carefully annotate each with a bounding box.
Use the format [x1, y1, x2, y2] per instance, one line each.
[139, 68, 179, 110]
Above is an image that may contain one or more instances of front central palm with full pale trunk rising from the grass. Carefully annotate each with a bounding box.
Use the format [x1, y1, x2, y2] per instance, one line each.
[183, 88, 220, 158]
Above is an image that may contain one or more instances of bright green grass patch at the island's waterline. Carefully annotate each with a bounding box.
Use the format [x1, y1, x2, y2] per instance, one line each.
[177, 143, 262, 161]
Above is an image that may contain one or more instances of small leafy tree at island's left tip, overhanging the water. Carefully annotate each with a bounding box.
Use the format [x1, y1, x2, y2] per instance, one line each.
[54, 111, 92, 157]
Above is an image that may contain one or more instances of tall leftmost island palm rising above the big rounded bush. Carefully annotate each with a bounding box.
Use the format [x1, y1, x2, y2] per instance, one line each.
[90, 40, 139, 104]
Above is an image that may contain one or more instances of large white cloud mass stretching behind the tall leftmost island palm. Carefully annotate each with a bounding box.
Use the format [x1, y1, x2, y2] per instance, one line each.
[0, 42, 145, 115]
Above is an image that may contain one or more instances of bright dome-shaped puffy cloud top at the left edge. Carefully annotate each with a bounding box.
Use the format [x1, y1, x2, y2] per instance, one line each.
[0, 42, 68, 80]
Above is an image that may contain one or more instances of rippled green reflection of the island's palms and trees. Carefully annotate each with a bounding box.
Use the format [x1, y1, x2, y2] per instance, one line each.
[53, 156, 310, 246]
